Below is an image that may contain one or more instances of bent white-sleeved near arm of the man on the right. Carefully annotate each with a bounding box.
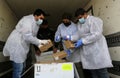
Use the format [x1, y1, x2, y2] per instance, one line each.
[81, 18, 103, 44]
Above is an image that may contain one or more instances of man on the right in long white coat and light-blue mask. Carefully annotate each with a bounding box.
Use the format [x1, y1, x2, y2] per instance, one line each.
[65, 8, 113, 78]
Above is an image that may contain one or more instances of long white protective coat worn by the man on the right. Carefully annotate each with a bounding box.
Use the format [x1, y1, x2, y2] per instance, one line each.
[72, 15, 113, 69]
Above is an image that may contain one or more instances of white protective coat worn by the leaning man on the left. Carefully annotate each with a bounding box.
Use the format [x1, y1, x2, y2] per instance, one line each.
[3, 15, 40, 63]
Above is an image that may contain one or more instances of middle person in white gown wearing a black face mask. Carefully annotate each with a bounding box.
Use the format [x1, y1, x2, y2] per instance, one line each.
[55, 13, 80, 62]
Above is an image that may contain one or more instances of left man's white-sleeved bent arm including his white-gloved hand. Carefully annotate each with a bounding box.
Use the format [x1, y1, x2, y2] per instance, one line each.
[20, 19, 48, 46]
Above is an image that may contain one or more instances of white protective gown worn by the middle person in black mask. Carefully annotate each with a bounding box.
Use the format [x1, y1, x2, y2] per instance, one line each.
[55, 22, 80, 62]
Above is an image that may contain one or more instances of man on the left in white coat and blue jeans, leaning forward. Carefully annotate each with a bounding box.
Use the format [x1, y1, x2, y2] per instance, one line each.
[3, 9, 48, 78]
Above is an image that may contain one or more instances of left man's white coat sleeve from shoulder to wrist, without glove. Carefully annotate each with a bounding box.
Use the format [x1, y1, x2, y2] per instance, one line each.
[16, 17, 39, 46]
